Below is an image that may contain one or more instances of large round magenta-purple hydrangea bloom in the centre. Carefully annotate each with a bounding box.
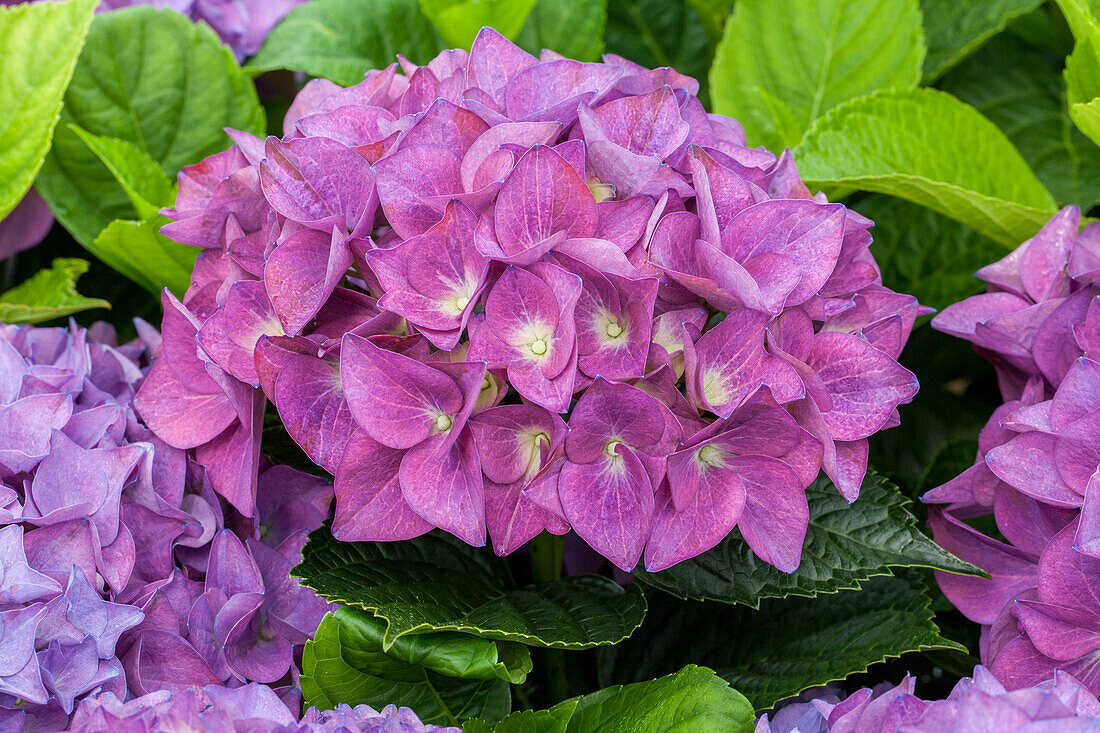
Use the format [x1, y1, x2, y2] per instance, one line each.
[139, 29, 923, 571]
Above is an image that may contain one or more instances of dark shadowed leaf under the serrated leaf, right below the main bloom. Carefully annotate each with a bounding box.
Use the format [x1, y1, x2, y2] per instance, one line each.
[607, 571, 965, 710]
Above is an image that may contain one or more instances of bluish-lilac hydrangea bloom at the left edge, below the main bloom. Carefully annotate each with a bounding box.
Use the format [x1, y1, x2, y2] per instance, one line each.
[0, 321, 332, 730]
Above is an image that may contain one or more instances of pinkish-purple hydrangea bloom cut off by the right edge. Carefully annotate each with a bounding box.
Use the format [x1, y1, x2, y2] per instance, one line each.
[924, 207, 1100, 692]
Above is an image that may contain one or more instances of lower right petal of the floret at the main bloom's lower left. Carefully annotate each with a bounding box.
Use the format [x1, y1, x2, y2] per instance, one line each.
[399, 428, 485, 547]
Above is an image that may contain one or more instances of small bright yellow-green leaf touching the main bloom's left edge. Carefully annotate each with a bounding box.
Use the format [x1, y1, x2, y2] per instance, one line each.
[88, 216, 200, 297]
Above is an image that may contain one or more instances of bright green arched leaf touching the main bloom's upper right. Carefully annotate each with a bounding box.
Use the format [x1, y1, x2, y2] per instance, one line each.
[794, 89, 1057, 247]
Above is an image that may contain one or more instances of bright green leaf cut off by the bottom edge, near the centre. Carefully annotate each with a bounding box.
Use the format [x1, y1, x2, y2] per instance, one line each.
[463, 665, 755, 733]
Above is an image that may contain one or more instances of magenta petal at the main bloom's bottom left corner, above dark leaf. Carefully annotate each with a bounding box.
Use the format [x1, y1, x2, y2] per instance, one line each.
[332, 430, 432, 541]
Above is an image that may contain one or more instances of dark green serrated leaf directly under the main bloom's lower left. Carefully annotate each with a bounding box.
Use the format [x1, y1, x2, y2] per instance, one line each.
[293, 526, 646, 649]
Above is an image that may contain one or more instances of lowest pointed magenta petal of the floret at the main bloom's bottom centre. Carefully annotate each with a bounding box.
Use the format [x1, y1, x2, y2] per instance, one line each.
[558, 445, 655, 571]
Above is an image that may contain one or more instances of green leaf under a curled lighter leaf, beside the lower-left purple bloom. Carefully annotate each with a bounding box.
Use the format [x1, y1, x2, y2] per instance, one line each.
[299, 609, 512, 725]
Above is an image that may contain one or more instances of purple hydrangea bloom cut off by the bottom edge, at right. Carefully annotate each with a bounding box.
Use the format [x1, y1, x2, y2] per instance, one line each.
[756, 666, 1100, 733]
